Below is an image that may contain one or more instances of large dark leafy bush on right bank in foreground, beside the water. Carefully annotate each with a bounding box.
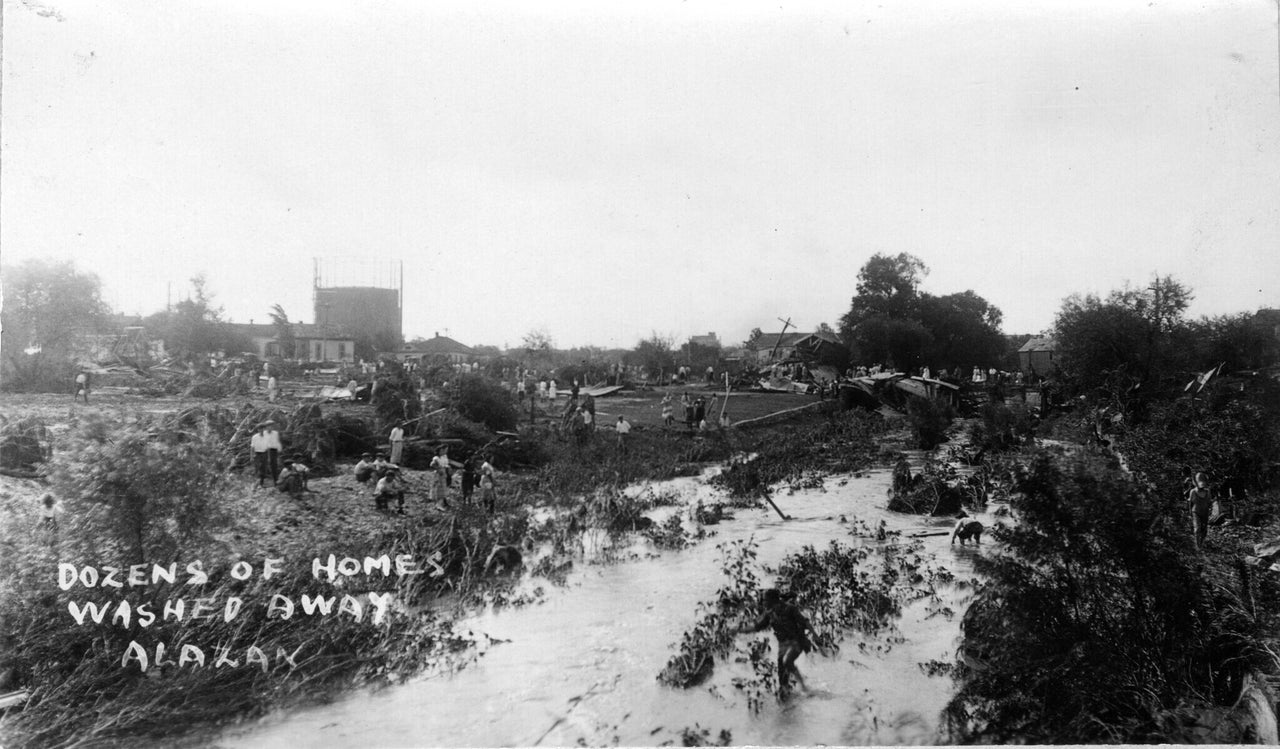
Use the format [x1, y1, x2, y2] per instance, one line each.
[947, 452, 1260, 744]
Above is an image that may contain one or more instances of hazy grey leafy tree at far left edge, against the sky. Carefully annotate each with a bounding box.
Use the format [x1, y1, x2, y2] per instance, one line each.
[0, 260, 109, 391]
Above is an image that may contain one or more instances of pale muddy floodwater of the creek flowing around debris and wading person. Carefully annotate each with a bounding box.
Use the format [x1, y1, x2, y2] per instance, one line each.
[221, 456, 996, 749]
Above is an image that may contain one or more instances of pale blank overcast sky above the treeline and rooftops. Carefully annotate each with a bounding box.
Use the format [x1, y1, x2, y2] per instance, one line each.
[0, 0, 1280, 347]
